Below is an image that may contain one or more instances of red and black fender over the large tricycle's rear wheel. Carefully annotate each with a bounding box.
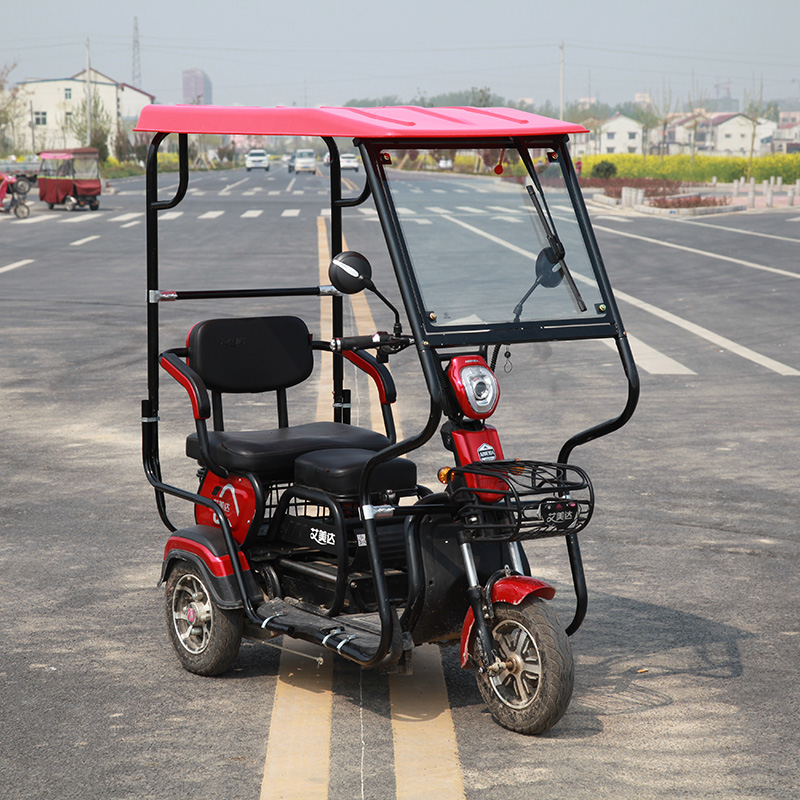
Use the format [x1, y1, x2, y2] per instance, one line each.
[159, 525, 262, 608]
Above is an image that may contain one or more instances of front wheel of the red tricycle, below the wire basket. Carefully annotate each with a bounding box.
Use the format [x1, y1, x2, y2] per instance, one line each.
[477, 597, 574, 735]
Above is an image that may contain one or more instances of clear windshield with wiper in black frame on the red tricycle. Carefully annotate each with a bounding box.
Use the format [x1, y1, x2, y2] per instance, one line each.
[385, 148, 606, 333]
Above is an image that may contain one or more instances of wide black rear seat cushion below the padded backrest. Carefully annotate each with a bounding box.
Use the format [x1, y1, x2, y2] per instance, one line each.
[186, 422, 389, 481]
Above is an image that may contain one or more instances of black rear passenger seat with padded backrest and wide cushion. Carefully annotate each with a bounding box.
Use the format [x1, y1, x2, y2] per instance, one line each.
[172, 316, 390, 481]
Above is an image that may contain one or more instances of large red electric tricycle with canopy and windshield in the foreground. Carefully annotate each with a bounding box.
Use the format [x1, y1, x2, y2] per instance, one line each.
[137, 105, 639, 734]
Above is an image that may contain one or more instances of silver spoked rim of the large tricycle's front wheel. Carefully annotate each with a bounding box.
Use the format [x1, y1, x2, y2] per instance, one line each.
[489, 620, 542, 709]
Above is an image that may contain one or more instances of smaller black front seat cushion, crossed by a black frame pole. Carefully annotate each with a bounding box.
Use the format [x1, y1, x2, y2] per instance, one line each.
[294, 448, 417, 497]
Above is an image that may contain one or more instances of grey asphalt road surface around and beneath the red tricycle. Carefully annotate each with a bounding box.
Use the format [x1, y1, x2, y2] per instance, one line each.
[0, 159, 800, 800]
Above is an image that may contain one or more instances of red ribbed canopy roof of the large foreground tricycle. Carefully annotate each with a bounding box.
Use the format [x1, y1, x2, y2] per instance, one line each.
[135, 105, 586, 139]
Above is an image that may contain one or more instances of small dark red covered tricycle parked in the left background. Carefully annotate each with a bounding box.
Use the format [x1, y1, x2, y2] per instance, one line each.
[36, 147, 101, 211]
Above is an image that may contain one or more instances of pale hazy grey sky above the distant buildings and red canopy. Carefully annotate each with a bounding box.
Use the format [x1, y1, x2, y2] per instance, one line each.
[0, 0, 800, 107]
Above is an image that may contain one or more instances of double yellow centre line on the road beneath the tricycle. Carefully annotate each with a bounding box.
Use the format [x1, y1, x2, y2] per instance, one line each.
[260, 217, 465, 800]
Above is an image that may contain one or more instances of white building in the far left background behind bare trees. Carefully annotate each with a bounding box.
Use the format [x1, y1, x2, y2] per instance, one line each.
[3, 69, 155, 158]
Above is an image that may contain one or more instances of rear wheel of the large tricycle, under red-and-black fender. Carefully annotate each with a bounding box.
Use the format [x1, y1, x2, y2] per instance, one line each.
[164, 562, 243, 675]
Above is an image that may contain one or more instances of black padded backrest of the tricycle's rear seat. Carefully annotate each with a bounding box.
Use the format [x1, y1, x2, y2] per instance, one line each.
[186, 317, 314, 393]
